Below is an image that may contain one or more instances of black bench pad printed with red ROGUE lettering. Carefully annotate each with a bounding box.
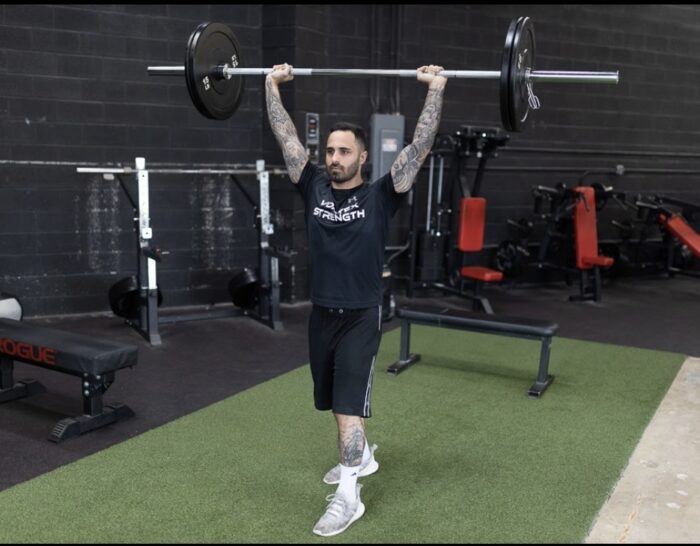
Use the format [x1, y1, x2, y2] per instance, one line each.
[0, 319, 138, 376]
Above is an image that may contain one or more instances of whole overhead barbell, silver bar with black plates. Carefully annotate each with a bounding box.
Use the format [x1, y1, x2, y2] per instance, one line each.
[148, 17, 619, 132]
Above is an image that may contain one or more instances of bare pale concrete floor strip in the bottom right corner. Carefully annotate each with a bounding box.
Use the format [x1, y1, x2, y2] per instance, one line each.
[585, 358, 700, 544]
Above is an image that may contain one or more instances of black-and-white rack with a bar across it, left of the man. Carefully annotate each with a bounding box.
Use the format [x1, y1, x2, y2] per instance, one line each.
[77, 157, 283, 345]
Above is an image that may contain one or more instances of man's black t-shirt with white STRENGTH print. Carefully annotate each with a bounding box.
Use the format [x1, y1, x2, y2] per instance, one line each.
[297, 161, 403, 309]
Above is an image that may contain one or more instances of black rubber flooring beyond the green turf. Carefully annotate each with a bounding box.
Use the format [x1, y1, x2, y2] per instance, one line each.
[0, 277, 700, 490]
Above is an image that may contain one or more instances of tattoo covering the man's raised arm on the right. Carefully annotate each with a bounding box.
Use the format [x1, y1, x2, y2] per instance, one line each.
[391, 87, 445, 193]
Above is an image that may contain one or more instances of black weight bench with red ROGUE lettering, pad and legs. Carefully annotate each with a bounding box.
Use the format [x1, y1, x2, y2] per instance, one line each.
[0, 319, 138, 442]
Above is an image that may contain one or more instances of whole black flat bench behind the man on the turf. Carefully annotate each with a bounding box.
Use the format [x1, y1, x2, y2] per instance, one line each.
[387, 306, 559, 398]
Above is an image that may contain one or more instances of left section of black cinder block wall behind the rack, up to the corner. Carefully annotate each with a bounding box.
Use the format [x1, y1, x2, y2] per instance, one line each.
[0, 4, 268, 316]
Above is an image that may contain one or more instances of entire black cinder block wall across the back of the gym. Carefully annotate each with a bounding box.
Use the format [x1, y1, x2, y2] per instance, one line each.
[0, 4, 700, 316]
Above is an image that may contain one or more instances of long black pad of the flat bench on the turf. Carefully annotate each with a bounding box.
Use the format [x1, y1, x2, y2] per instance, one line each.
[396, 306, 559, 337]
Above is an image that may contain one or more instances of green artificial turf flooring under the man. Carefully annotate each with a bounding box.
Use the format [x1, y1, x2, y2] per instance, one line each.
[0, 326, 684, 543]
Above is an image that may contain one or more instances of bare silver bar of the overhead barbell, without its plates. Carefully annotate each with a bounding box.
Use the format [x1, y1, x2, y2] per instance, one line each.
[148, 66, 620, 83]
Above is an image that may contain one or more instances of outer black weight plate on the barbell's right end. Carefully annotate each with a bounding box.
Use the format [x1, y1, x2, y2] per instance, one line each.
[509, 17, 535, 132]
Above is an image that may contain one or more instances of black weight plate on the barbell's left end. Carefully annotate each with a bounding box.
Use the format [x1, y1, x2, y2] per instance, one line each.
[185, 23, 243, 120]
